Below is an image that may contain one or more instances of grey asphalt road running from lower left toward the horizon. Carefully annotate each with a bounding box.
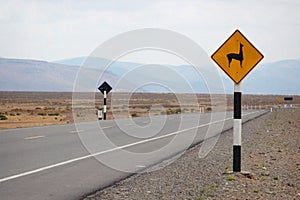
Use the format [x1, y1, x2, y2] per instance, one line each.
[0, 110, 267, 200]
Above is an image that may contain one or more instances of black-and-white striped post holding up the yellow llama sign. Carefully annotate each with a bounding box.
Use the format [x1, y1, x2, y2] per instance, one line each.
[233, 82, 242, 172]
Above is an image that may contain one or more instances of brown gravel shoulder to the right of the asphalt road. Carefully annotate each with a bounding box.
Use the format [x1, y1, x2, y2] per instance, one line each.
[85, 109, 300, 200]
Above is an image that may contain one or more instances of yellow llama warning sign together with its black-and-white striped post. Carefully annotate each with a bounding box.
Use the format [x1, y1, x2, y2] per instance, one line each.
[211, 30, 264, 172]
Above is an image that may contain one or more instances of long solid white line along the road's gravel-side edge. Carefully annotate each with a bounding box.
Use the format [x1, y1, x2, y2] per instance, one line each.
[0, 111, 259, 183]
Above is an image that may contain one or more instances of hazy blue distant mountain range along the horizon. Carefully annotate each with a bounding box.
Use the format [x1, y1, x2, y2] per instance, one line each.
[0, 57, 300, 95]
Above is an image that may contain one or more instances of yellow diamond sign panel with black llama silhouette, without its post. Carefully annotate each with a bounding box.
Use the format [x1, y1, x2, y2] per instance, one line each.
[211, 30, 264, 84]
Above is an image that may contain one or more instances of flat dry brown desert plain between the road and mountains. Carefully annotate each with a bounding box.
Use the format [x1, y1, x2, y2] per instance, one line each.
[0, 91, 300, 129]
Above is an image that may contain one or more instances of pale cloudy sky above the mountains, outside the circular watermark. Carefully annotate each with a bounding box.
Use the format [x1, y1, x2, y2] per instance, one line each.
[0, 0, 300, 62]
